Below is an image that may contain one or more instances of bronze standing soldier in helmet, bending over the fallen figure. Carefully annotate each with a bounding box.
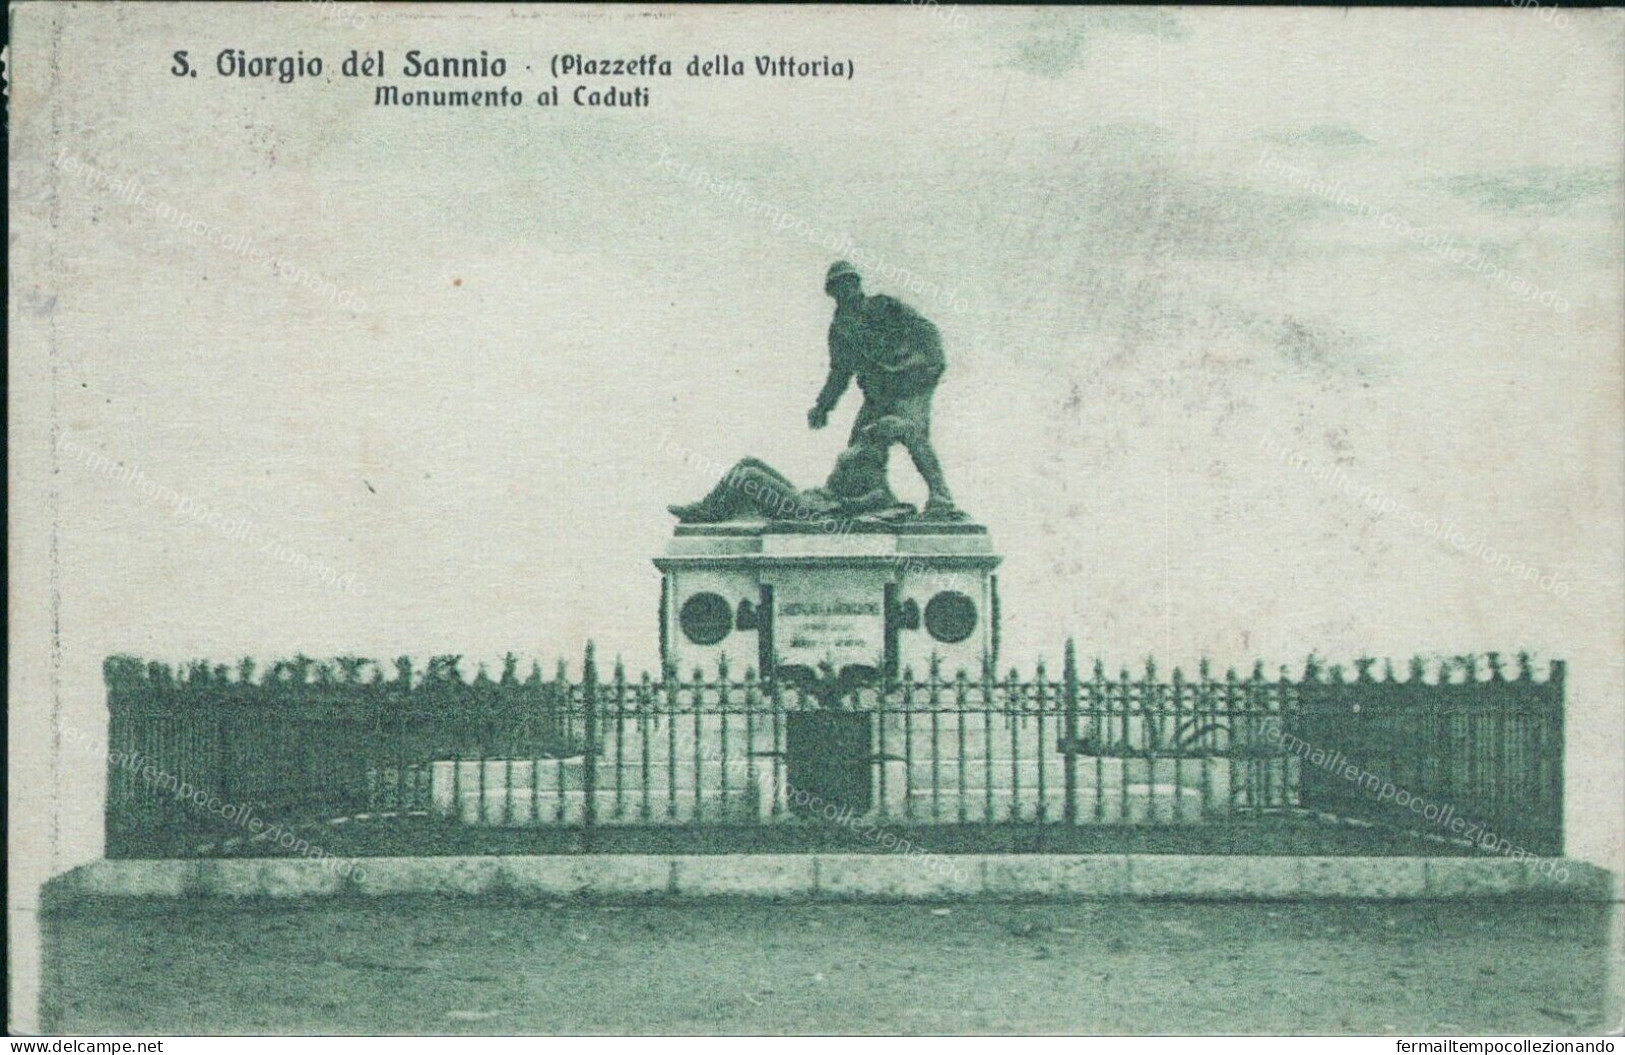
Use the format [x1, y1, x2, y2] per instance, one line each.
[808, 260, 965, 520]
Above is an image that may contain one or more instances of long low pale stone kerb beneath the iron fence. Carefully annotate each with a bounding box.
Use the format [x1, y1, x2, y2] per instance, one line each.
[46, 853, 1615, 905]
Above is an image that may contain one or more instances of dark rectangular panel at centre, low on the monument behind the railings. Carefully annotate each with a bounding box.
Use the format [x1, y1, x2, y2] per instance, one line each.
[785, 710, 874, 816]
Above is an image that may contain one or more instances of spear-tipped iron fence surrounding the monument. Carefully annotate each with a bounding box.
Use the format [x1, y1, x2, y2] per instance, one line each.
[106, 642, 1565, 857]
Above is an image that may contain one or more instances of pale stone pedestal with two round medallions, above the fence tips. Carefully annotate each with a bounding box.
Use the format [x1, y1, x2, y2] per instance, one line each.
[655, 522, 999, 679]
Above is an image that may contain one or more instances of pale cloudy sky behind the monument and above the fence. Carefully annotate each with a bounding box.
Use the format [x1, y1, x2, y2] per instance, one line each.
[11, 5, 1625, 865]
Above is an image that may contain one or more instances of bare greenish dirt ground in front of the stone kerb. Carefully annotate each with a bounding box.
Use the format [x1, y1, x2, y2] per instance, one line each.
[42, 897, 1610, 1035]
